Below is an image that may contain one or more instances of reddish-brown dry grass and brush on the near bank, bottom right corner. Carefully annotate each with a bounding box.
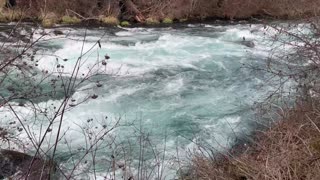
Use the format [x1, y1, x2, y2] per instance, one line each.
[188, 103, 320, 180]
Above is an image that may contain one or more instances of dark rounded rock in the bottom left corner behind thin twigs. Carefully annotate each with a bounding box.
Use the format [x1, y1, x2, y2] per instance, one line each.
[0, 150, 55, 179]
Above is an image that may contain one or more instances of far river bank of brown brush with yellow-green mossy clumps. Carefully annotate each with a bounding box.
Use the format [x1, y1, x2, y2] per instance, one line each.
[0, 0, 320, 27]
